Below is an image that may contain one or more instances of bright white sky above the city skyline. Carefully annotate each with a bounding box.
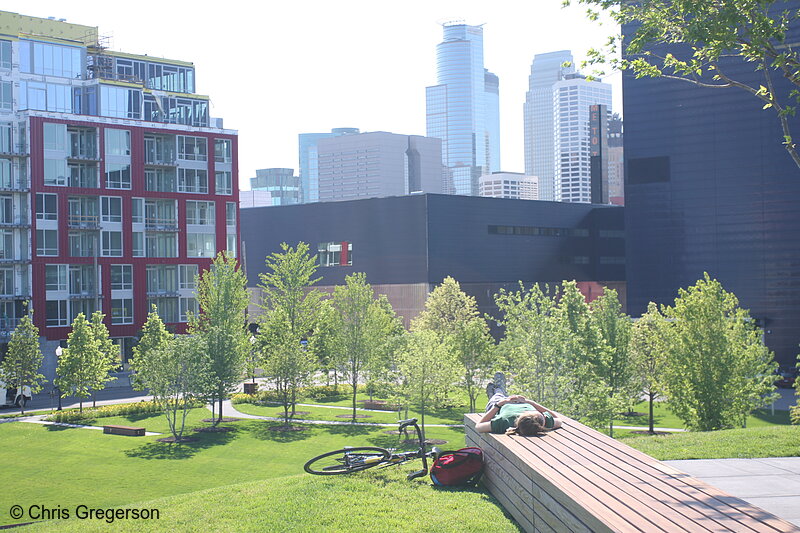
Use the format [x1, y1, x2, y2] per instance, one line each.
[14, 0, 622, 189]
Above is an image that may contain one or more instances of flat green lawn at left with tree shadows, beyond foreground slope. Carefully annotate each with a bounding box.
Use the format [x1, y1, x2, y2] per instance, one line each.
[0, 409, 464, 525]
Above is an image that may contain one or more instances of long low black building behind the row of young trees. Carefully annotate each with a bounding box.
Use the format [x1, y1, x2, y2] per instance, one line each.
[241, 194, 625, 324]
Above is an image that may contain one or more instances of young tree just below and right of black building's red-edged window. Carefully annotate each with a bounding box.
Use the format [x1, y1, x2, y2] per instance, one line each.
[330, 272, 398, 421]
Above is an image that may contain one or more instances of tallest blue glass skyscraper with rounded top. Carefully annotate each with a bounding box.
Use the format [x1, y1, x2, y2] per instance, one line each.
[425, 23, 500, 195]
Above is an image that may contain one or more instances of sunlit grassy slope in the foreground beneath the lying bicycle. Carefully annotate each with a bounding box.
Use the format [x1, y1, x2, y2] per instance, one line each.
[23, 467, 519, 533]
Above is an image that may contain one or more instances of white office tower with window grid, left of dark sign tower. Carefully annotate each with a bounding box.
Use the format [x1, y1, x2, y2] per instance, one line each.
[552, 74, 611, 203]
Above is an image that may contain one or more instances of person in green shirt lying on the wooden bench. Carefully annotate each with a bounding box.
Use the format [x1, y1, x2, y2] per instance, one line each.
[475, 372, 561, 437]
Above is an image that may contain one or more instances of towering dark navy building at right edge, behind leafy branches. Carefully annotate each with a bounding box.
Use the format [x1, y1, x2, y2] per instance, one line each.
[623, 11, 800, 366]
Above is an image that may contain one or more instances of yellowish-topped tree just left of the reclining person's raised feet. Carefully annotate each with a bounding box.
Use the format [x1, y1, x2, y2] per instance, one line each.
[411, 276, 496, 412]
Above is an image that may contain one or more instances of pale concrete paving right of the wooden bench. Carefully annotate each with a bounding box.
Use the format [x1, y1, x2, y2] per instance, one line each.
[664, 457, 800, 531]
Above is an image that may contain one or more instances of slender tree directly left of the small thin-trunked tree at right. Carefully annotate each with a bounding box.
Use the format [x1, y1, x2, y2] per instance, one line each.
[589, 287, 641, 437]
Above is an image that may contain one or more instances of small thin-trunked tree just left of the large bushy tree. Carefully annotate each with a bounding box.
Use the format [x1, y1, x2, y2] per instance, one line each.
[629, 302, 668, 434]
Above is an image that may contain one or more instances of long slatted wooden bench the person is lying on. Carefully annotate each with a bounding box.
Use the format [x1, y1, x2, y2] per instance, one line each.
[464, 414, 800, 533]
